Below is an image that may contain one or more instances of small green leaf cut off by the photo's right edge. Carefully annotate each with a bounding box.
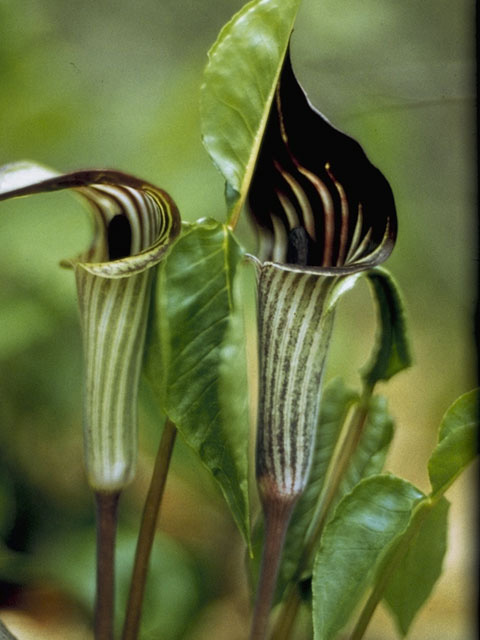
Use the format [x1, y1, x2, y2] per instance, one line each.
[428, 389, 480, 494]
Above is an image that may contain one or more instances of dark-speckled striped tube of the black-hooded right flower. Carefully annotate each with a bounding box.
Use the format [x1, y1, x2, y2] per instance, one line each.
[256, 263, 336, 502]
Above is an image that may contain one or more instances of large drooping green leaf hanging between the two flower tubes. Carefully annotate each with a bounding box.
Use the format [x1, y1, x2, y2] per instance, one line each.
[147, 220, 249, 540]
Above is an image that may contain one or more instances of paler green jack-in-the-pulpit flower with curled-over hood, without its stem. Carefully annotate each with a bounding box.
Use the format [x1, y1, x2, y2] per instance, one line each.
[0, 162, 180, 492]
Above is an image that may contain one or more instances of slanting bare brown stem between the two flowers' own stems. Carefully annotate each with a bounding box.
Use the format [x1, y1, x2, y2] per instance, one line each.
[122, 419, 177, 640]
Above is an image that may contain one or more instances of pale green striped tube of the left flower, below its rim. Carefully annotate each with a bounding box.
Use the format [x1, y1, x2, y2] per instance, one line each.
[75, 265, 153, 491]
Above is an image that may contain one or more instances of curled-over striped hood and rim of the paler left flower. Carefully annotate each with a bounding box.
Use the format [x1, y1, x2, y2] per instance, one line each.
[0, 162, 181, 278]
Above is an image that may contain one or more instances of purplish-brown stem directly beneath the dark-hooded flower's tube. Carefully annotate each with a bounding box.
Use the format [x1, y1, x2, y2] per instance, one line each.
[250, 498, 296, 640]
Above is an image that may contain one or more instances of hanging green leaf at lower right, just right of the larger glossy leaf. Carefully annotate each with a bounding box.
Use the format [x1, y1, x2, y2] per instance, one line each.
[384, 498, 450, 636]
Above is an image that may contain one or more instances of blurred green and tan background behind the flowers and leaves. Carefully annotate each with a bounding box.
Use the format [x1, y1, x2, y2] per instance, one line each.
[0, 0, 477, 640]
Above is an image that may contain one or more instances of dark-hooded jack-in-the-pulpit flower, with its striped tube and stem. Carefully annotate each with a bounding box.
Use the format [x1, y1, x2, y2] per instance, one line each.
[249, 48, 397, 639]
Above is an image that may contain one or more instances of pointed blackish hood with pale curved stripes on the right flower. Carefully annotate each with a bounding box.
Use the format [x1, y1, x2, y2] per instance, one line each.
[248, 47, 397, 275]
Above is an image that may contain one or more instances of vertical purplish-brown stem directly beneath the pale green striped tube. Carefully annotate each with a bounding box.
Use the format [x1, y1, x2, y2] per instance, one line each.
[95, 491, 120, 640]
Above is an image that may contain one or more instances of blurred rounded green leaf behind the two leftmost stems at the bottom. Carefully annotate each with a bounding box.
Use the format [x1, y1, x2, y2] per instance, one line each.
[33, 526, 199, 640]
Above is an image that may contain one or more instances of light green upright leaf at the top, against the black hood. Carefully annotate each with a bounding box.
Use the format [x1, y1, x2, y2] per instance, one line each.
[200, 0, 300, 219]
